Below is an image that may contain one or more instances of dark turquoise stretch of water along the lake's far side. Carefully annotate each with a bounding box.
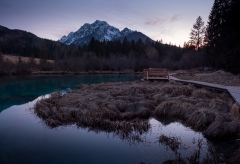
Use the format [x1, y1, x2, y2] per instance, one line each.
[0, 75, 141, 112]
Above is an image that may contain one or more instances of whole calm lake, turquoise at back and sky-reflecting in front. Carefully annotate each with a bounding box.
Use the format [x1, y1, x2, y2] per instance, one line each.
[0, 75, 232, 164]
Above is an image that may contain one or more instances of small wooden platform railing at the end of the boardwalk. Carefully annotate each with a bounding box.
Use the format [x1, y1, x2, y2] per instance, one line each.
[143, 68, 169, 80]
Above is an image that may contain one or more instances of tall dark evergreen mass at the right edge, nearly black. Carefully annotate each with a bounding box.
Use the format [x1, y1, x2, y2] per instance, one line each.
[205, 0, 240, 73]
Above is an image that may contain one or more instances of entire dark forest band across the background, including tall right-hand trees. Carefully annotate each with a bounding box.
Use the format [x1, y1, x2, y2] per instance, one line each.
[0, 0, 240, 74]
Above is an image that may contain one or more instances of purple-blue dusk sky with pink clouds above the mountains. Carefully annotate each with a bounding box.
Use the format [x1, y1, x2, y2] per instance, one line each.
[0, 0, 214, 46]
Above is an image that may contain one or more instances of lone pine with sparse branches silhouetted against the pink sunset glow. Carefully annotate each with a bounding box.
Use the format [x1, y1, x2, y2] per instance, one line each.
[189, 16, 205, 50]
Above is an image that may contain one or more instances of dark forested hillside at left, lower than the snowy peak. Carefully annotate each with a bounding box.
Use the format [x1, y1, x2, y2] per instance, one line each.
[0, 25, 71, 59]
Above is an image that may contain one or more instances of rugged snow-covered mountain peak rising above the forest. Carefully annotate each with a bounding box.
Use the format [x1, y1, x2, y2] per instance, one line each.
[59, 20, 152, 46]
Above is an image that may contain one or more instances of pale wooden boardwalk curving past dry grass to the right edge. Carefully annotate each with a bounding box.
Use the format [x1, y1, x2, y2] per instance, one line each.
[170, 76, 240, 105]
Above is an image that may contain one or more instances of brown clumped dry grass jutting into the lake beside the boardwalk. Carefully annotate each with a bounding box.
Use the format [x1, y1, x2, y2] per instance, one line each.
[35, 81, 239, 138]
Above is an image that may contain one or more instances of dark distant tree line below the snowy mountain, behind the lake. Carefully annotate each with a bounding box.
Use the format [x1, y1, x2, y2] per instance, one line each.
[0, 35, 204, 74]
